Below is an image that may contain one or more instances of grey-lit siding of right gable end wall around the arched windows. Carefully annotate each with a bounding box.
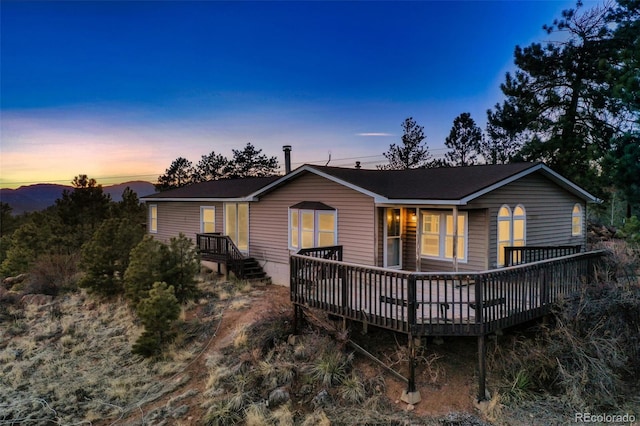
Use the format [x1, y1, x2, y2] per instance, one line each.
[469, 173, 586, 268]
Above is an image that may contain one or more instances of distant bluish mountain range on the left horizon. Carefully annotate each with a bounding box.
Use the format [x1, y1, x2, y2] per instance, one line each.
[0, 181, 156, 215]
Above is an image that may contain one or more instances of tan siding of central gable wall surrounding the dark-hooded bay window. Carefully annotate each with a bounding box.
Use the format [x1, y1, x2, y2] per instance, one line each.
[249, 173, 376, 285]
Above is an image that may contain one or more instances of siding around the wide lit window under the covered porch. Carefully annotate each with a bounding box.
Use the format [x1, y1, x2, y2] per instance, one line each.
[418, 208, 489, 272]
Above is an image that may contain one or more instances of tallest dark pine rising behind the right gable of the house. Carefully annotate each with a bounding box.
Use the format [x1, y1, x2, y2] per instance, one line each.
[488, 3, 625, 193]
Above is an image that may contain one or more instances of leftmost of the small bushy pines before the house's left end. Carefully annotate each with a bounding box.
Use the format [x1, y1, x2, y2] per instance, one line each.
[79, 218, 144, 296]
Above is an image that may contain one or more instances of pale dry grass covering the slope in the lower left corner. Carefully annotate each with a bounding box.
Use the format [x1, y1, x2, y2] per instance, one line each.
[0, 292, 198, 424]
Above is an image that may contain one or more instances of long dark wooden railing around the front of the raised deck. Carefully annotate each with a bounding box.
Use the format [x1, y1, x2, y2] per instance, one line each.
[290, 251, 605, 336]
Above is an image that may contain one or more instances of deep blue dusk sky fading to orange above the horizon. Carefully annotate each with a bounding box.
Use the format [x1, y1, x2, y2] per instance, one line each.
[0, 0, 594, 187]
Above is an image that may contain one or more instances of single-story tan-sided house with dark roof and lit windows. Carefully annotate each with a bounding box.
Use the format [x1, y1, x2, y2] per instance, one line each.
[142, 163, 598, 285]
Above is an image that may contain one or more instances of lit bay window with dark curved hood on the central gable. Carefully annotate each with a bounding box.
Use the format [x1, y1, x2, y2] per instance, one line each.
[289, 201, 338, 249]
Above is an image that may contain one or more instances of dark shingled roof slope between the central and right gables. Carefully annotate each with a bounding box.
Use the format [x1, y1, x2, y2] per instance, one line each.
[310, 163, 537, 200]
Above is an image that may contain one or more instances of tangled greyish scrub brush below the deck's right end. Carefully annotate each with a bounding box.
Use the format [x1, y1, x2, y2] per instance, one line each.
[492, 250, 640, 410]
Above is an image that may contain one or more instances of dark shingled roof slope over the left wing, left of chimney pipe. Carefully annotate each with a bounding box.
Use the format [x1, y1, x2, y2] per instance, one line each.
[143, 176, 282, 200]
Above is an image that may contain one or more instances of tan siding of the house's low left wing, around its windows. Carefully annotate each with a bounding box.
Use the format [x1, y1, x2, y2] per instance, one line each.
[147, 201, 224, 243]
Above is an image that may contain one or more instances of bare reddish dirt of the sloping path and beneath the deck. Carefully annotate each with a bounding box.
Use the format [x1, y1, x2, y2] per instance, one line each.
[105, 285, 477, 426]
